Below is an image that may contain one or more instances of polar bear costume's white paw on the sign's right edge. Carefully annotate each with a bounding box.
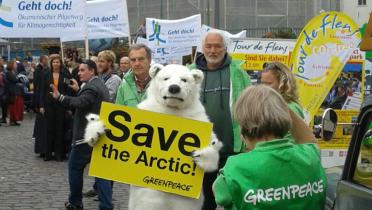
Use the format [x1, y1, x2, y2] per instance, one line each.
[192, 139, 222, 172]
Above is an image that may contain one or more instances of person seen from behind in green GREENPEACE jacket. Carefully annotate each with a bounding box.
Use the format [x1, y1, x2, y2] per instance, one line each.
[213, 85, 327, 210]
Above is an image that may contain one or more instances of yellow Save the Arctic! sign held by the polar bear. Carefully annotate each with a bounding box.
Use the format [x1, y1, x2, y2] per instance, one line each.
[89, 103, 212, 198]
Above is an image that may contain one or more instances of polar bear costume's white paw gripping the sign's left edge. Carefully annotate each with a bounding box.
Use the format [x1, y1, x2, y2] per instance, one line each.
[84, 114, 108, 147]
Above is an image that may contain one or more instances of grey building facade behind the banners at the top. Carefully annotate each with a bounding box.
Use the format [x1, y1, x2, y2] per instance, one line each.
[127, 0, 340, 37]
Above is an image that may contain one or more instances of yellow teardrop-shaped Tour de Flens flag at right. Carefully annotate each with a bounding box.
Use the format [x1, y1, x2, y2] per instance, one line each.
[291, 12, 361, 122]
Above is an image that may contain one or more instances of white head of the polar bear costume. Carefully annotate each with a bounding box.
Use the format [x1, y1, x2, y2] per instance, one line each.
[147, 64, 204, 109]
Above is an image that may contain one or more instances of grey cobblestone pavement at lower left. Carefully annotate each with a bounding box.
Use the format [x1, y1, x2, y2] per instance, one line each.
[0, 113, 128, 210]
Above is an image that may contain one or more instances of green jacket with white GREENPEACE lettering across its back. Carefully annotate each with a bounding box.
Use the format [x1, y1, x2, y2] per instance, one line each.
[214, 138, 327, 210]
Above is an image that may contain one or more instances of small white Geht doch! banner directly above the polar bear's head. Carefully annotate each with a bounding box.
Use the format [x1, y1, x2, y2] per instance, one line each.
[146, 14, 201, 49]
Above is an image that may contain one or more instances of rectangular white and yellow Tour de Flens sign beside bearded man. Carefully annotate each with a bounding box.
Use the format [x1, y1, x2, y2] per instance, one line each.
[228, 38, 295, 71]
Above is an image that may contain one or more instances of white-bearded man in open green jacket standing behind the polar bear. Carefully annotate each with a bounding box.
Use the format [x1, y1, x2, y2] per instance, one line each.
[189, 30, 251, 210]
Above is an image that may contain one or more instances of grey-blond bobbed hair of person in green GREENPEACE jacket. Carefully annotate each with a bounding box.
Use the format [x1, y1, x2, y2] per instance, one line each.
[234, 85, 292, 139]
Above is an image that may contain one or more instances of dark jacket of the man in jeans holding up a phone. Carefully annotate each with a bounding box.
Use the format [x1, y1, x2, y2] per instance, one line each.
[60, 77, 110, 141]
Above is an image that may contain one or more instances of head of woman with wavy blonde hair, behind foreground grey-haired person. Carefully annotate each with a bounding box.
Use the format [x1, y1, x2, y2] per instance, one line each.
[261, 62, 304, 118]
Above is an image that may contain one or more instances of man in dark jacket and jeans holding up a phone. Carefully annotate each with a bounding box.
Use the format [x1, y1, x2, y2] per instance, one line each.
[51, 60, 113, 210]
